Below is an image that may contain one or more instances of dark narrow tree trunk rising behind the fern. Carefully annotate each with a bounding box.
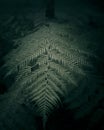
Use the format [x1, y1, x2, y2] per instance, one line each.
[45, 0, 55, 18]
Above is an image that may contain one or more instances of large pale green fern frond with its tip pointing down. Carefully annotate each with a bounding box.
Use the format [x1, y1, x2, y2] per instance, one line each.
[1, 23, 100, 127]
